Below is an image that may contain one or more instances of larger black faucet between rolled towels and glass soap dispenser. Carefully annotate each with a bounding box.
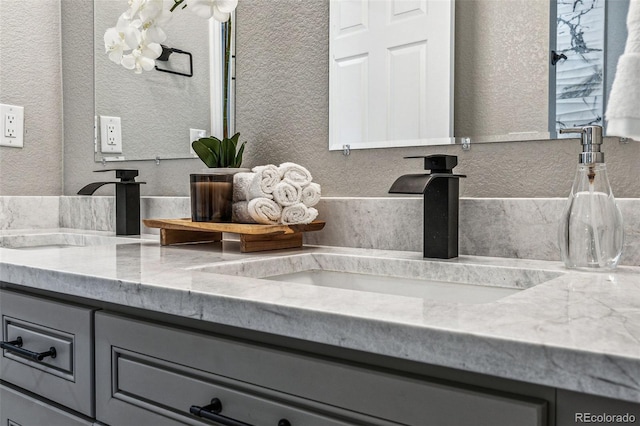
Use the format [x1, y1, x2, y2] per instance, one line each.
[389, 155, 466, 259]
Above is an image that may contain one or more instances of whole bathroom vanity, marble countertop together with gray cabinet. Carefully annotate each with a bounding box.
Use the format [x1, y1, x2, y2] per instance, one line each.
[0, 230, 640, 426]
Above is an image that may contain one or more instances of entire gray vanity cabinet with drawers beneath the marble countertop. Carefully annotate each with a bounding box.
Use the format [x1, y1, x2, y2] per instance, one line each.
[8, 289, 640, 426]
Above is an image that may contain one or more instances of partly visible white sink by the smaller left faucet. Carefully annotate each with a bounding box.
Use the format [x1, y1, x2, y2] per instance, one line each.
[0, 232, 149, 250]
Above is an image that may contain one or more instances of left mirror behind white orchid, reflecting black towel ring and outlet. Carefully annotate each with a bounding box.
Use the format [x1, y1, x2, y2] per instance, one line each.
[94, 0, 235, 161]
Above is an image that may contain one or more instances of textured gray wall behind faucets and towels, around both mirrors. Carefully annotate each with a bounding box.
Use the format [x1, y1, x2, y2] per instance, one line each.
[62, 0, 640, 197]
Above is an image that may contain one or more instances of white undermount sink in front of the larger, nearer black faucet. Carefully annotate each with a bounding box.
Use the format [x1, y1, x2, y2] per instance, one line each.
[192, 253, 562, 304]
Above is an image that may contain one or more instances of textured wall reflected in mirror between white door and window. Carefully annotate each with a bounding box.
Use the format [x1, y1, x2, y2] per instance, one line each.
[454, 0, 550, 137]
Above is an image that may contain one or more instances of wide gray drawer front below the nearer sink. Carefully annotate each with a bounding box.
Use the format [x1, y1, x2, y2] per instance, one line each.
[95, 311, 547, 426]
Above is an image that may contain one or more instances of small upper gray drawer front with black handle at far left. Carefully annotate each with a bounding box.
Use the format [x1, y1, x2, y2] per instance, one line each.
[0, 290, 95, 417]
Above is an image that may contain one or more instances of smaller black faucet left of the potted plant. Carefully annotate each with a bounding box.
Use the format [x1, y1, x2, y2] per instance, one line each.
[78, 169, 146, 235]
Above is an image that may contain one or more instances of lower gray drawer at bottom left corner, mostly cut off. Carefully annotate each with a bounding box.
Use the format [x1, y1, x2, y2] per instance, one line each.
[0, 385, 93, 426]
